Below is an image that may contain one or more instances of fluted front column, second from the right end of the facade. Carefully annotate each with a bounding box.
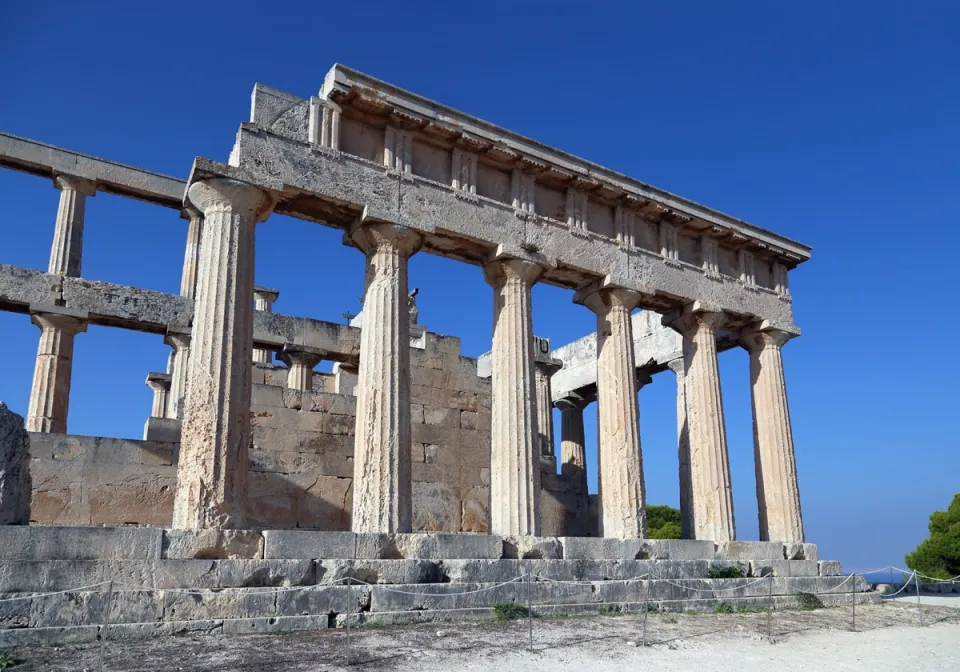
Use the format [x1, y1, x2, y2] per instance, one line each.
[670, 308, 736, 541]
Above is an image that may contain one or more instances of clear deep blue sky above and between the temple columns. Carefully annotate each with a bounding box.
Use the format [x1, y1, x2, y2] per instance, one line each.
[0, 0, 960, 570]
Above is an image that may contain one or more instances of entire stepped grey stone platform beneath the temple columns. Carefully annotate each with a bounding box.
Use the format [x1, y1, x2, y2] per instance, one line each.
[0, 526, 879, 646]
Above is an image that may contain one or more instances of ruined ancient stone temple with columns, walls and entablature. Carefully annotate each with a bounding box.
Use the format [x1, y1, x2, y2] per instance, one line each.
[0, 65, 868, 644]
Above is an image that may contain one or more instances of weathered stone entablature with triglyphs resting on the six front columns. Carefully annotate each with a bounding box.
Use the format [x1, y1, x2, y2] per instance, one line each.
[231, 72, 809, 327]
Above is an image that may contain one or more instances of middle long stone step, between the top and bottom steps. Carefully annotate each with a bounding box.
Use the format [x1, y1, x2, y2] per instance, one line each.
[0, 559, 840, 593]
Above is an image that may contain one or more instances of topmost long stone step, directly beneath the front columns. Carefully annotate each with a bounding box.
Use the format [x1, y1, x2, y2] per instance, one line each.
[0, 526, 818, 562]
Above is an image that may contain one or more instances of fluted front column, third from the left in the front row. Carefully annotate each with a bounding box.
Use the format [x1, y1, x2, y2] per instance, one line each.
[483, 259, 543, 536]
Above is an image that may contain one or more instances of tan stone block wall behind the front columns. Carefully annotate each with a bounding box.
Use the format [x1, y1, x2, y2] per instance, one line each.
[31, 332, 575, 534]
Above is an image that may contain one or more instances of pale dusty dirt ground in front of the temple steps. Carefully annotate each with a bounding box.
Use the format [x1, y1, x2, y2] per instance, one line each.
[3, 602, 960, 672]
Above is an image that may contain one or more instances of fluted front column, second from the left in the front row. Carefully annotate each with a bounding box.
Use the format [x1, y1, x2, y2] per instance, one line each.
[351, 223, 423, 532]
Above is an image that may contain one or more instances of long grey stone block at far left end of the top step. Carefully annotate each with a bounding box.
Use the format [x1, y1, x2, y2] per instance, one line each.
[0, 525, 163, 561]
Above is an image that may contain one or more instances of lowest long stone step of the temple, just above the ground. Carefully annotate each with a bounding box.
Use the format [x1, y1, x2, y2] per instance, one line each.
[0, 577, 868, 646]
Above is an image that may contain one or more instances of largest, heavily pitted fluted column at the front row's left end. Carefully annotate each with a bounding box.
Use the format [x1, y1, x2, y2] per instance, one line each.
[173, 178, 272, 529]
